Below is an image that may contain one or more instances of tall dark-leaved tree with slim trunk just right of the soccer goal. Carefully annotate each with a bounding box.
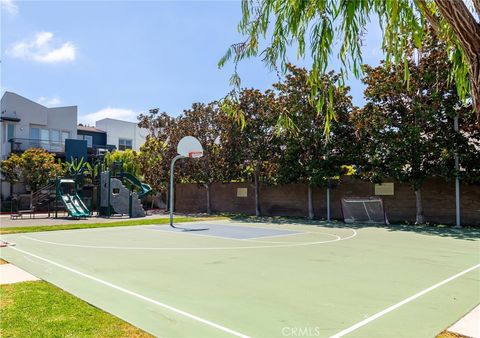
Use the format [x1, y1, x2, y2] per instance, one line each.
[353, 35, 479, 224]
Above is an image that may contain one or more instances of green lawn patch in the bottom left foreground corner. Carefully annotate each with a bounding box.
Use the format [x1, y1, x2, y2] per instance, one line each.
[0, 281, 151, 337]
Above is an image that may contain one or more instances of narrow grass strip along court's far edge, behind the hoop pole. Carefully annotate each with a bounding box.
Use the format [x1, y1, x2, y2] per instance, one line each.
[0, 216, 226, 235]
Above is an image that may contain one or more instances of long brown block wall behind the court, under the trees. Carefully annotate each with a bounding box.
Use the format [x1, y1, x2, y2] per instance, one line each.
[175, 177, 480, 226]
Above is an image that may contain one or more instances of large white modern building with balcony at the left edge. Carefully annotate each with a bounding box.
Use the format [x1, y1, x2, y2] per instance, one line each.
[0, 92, 77, 196]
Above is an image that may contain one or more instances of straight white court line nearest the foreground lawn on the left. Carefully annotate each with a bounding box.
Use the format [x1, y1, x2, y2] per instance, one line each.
[9, 247, 250, 338]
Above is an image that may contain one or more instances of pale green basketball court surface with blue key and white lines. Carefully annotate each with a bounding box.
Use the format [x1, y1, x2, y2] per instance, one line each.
[0, 220, 480, 337]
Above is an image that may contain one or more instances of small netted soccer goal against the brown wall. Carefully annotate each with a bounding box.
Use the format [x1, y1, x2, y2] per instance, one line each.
[342, 197, 388, 224]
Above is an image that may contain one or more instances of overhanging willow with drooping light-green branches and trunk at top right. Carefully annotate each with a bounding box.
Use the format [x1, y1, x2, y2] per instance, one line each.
[219, 0, 480, 126]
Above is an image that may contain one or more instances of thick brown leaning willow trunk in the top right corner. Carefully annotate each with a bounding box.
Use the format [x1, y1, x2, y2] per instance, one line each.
[436, 0, 480, 119]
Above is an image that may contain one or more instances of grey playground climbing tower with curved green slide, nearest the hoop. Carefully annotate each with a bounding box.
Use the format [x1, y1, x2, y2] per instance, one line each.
[97, 162, 152, 217]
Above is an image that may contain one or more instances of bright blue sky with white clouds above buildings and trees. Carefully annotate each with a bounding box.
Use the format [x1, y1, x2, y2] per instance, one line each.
[0, 0, 381, 124]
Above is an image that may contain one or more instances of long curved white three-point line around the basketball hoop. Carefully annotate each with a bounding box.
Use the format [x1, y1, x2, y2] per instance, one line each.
[21, 229, 357, 251]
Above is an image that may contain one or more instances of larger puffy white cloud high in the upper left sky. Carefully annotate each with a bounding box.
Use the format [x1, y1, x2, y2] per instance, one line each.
[7, 32, 77, 63]
